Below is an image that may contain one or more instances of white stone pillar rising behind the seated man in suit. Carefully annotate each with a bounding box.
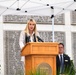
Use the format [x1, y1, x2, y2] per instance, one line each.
[65, 11, 73, 59]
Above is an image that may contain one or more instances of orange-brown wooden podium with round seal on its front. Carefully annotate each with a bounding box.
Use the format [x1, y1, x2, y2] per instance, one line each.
[21, 42, 58, 75]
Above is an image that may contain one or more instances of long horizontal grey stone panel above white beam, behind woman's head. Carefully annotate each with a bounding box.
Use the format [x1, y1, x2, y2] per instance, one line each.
[3, 14, 65, 25]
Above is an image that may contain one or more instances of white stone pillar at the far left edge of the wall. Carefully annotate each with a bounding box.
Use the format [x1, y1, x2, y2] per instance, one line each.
[0, 16, 4, 75]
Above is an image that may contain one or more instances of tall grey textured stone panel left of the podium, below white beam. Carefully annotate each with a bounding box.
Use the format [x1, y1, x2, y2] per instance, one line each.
[4, 31, 23, 75]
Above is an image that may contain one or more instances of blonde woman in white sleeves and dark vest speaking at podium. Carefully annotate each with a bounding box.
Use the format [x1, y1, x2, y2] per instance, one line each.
[19, 19, 43, 62]
